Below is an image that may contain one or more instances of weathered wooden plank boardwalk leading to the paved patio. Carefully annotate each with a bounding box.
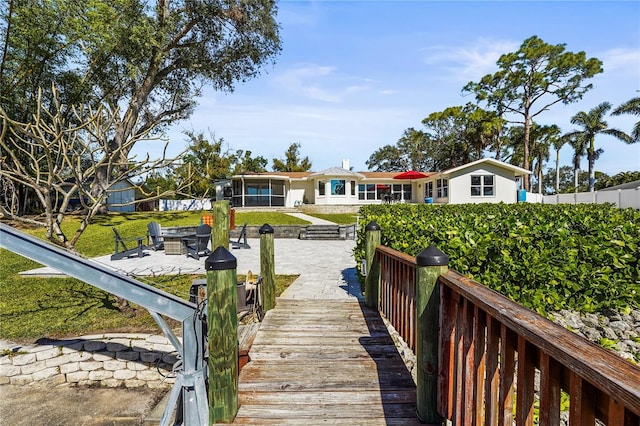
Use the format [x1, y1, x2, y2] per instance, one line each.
[234, 299, 420, 425]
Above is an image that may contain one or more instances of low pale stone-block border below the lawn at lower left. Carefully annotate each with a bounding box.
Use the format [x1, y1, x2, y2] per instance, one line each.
[0, 333, 178, 388]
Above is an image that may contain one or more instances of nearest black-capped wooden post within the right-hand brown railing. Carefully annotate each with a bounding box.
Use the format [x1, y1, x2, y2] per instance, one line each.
[416, 246, 449, 424]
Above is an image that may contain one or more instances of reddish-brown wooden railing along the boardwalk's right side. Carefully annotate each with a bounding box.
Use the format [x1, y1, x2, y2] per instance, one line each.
[366, 221, 640, 426]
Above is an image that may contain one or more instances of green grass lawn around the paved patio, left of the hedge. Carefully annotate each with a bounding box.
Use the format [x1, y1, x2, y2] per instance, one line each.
[0, 212, 300, 341]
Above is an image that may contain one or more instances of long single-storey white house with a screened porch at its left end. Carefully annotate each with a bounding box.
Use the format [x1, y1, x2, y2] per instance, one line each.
[231, 158, 530, 207]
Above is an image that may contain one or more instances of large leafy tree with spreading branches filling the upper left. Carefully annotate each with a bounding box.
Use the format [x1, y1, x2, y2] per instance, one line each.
[0, 0, 280, 248]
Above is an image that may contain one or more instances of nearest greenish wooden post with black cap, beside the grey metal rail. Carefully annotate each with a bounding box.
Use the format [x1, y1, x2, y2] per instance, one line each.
[205, 247, 238, 425]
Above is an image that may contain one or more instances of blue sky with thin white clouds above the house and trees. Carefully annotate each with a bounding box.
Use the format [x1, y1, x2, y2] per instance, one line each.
[139, 1, 640, 174]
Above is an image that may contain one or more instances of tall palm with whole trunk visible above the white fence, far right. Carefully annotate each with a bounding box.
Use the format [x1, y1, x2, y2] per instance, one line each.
[569, 102, 633, 192]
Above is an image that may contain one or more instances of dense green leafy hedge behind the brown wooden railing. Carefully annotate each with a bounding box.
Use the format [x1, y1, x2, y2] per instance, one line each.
[355, 203, 640, 314]
